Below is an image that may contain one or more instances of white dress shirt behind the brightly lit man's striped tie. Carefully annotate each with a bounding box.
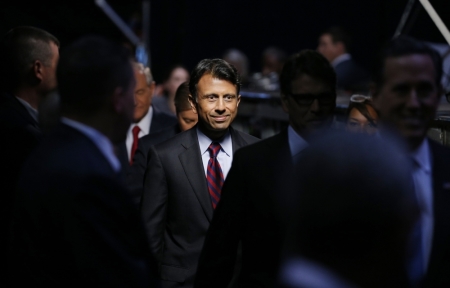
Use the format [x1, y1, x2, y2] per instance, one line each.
[197, 126, 233, 180]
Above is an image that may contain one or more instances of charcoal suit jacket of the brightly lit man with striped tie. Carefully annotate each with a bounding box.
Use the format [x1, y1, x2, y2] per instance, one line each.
[141, 126, 257, 287]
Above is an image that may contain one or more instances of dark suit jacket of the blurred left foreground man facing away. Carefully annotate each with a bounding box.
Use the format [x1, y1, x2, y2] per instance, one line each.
[13, 124, 156, 287]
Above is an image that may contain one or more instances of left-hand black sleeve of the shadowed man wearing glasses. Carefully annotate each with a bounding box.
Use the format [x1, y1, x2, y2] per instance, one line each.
[194, 151, 246, 288]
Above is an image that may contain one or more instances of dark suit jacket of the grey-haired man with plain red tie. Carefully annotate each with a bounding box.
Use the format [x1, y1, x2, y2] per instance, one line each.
[127, 124, 180, 207]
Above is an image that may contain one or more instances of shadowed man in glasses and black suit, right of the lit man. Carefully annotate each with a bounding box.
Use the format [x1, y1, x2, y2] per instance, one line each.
[194, 50, 336, 287]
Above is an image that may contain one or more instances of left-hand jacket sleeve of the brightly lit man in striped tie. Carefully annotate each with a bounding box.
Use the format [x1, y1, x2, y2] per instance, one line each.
[141, 146, 169, 262]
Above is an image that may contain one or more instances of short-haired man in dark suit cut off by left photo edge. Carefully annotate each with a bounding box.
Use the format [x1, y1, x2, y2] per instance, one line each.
[0, 27, 59, 278]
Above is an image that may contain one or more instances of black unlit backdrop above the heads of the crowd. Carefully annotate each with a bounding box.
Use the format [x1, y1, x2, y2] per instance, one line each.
[0, 0, 450, 82]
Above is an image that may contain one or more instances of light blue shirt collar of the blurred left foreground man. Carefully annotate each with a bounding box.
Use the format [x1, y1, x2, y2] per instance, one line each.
[61, 117, 120, 172]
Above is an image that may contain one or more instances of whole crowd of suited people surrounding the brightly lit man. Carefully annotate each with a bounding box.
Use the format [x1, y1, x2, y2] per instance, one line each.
[0, 26, 450, 288]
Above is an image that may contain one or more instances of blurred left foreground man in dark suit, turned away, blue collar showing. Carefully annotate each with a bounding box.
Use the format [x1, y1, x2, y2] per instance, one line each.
[12, 37, 156, 287]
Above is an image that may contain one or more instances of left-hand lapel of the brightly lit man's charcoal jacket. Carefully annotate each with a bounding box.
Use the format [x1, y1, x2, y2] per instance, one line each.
[178, 127, 214, 222]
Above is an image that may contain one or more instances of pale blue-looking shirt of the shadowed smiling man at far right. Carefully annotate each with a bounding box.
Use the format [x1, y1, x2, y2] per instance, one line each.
[411, 139, 434, 273]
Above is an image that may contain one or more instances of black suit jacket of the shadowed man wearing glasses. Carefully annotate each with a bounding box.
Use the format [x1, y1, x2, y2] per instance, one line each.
[194, 130, 293, 287]
